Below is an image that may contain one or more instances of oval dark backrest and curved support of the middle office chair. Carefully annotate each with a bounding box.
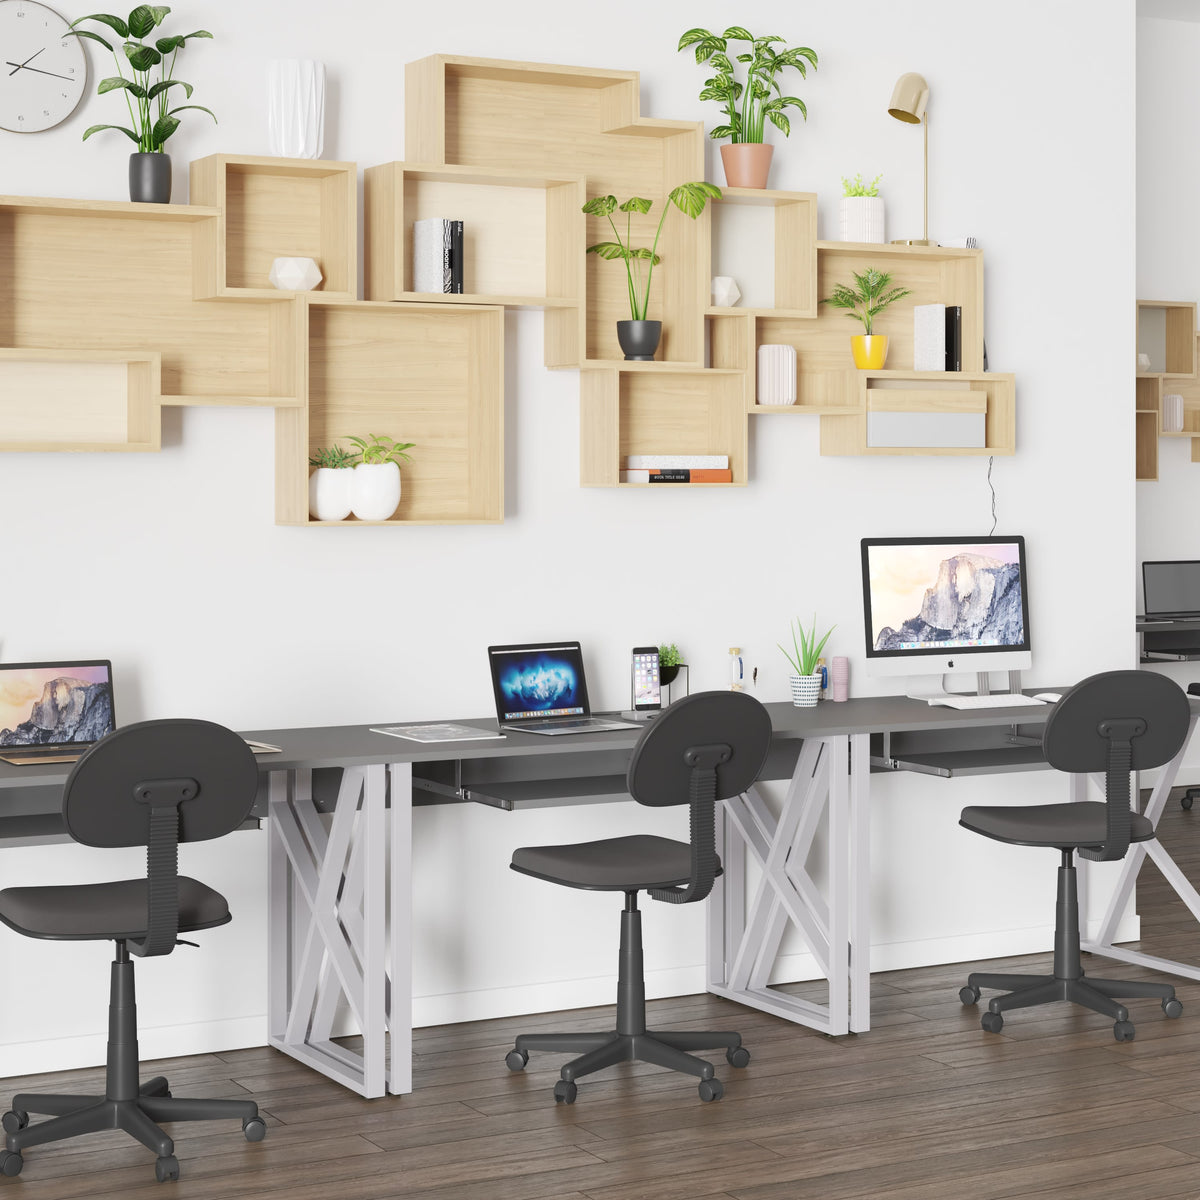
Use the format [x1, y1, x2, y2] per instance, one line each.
[626, 691, 770, 904]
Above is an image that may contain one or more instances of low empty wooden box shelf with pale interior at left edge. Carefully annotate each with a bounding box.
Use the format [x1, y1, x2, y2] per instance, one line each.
[0, 349, 162, 451]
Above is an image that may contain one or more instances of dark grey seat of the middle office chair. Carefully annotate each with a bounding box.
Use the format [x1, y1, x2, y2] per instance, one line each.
[511, 834, 721, 892]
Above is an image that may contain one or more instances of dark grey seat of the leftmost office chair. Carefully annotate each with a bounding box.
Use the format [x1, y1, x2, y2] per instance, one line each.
[0, 875, 229, 941]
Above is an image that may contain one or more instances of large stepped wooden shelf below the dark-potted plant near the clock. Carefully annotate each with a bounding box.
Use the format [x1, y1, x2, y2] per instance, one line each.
[0, 197, 300, 406]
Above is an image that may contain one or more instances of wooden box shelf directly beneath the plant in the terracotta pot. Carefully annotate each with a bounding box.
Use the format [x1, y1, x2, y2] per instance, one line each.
[706, 187, 817, 318]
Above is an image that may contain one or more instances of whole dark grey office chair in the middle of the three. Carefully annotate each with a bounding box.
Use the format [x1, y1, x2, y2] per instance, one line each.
[505, 691, 770, 1104]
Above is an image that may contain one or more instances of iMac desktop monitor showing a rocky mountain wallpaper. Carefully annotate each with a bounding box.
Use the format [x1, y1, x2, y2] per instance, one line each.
[863, 536, 1032, 676]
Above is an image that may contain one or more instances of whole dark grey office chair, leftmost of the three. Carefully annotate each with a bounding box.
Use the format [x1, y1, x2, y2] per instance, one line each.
[0, 720, 266, 1182]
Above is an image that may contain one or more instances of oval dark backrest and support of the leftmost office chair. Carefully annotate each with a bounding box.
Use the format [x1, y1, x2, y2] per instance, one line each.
[62, 720, 258, 955]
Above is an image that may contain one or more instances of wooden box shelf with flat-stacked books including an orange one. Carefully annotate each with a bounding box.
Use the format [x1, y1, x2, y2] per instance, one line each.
[580, 364, 748, 487]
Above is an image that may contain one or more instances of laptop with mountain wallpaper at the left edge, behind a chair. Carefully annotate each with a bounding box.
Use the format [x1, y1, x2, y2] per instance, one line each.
[0, 659, 116, 767]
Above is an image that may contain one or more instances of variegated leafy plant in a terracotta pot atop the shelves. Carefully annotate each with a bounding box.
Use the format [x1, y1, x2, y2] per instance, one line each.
[678, 25, 817, 187]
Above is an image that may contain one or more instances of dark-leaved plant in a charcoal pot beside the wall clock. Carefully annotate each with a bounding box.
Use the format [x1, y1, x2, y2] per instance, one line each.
[71, 4, 216, 204]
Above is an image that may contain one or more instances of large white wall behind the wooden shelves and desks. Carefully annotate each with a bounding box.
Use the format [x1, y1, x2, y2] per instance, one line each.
[0, 0, 1134, 1074]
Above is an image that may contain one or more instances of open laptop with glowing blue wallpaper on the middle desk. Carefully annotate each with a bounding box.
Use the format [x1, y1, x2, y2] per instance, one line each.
[487, 642, 638, 737]
